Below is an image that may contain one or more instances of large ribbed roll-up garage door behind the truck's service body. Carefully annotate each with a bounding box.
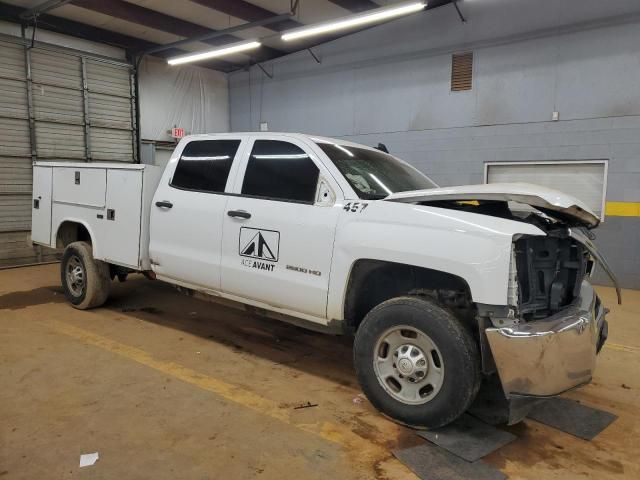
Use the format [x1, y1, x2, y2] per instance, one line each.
[0, 38, 137, 267]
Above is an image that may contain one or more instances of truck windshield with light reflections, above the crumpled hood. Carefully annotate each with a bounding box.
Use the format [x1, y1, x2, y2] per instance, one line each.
[317, 142, 437, 200]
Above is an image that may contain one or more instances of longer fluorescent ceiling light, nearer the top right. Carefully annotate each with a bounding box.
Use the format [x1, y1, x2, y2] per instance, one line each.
[281, 2, 426, 40]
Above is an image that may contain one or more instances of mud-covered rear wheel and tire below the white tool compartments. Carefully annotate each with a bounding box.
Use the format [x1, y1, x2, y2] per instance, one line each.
[60, 242, 111, 310]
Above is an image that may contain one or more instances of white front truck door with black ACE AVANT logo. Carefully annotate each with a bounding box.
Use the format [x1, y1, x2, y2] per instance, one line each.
[222, 137, 340, 318]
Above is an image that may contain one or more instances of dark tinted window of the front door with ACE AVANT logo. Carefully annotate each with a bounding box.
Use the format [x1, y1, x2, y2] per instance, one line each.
[241, 140, 320, 204]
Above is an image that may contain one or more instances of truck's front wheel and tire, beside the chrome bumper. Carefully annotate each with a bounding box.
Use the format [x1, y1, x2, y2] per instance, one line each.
[353, 297, 481, 428]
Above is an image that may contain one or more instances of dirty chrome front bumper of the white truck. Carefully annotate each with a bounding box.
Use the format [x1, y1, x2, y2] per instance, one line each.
[485, 281, 607, 398]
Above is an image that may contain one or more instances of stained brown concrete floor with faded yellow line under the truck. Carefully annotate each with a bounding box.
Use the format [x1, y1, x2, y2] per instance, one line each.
[0, 265, 640, 480]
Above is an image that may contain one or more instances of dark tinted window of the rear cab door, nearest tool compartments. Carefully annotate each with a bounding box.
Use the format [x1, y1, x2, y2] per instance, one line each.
[170, 139, 240, 193]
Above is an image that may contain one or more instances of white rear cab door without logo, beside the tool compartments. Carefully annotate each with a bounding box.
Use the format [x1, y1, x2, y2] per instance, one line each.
[149, 136, 248, 291]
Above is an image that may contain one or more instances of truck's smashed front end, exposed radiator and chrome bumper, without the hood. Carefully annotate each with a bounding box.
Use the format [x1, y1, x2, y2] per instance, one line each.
[478, 227, 619, 423]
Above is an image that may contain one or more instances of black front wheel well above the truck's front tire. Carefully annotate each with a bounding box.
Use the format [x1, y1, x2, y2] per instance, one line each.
[344, 259, 473, 331]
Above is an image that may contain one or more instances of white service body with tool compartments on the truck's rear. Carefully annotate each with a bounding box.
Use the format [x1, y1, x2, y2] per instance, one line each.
[32, 162, 162, 270]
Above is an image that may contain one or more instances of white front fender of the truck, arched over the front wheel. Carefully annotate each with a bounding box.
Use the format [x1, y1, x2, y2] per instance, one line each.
[327, 201, 545, 319]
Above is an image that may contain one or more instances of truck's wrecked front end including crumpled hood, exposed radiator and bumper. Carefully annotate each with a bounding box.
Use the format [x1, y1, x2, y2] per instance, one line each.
[385, 183, 621, 424]
